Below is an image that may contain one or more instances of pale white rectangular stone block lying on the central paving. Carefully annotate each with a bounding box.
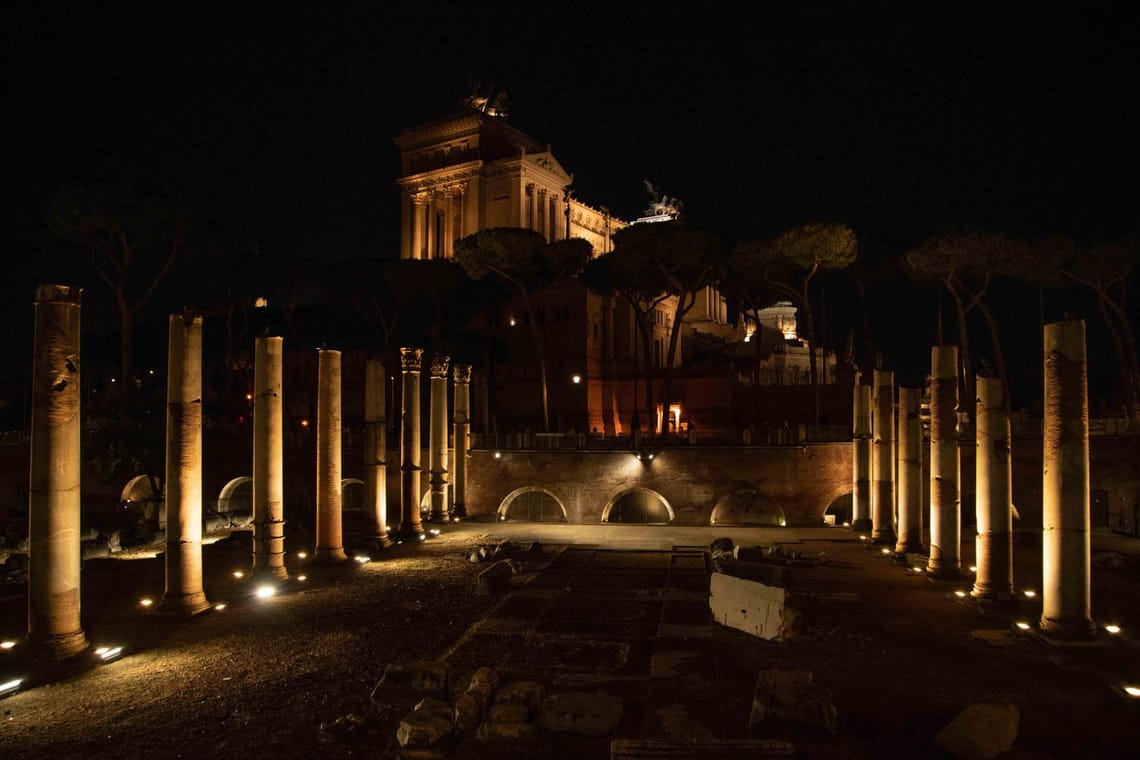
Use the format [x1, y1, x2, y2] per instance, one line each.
[709, 573, 803, 641]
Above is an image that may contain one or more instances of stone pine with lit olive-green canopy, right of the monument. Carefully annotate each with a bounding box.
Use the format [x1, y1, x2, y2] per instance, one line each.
[732, 222, 858, 424]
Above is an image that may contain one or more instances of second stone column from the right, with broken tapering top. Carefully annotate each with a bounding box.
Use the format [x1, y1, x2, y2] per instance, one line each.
[971, 377, 1013, 600]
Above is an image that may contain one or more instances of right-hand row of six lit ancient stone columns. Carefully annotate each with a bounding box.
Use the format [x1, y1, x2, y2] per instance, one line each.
[852, 320, 1096, 638]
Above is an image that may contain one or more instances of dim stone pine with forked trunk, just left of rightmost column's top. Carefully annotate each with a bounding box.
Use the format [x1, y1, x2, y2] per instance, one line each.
[903, 232, 1032, 418]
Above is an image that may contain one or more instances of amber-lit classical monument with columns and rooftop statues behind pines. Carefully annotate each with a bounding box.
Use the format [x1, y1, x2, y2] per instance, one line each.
[394, 105, 849, 435]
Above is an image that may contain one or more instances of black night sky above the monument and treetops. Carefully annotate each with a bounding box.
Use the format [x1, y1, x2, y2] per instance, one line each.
[2, 2, 1140, 410]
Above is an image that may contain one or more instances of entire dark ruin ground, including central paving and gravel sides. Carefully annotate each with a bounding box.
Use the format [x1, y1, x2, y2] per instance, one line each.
[0, 524, 1140, 758]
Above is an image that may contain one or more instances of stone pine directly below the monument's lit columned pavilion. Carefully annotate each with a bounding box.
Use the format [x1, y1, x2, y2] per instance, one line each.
[455, 227, 592, 433]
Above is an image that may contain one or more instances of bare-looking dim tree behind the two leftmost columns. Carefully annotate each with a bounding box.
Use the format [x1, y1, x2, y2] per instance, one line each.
[46, 185, 188, 395]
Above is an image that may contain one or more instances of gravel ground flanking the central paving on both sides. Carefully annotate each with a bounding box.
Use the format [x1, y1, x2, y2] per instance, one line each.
[0, 525, 1140, 759]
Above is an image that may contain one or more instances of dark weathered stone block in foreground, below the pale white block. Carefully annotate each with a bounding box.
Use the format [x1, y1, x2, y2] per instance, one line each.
[748, 670, 836, 734]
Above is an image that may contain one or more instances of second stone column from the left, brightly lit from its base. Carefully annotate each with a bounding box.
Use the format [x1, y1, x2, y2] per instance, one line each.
[162, 314, 210, 615]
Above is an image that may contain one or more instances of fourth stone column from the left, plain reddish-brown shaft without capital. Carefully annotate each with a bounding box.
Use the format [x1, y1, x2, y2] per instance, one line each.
[312, 349, 348, 562]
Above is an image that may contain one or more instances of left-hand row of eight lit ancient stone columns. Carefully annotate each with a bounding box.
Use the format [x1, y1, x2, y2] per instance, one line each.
[27, 285, 471, 661]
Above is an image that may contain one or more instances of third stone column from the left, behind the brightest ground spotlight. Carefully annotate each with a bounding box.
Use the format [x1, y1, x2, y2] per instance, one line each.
[253, 335, 288, 579]
